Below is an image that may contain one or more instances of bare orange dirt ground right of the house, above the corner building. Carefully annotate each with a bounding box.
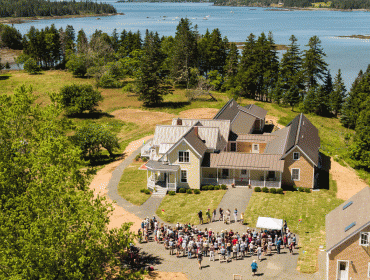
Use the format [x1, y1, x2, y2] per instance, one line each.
[330, 158, 367, 200]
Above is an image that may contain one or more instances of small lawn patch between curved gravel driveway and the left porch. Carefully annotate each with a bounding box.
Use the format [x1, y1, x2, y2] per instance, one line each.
[118, 161, 150, 205]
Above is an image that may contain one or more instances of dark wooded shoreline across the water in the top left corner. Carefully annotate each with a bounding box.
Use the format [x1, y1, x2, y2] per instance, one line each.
[0, 0, 117, 17]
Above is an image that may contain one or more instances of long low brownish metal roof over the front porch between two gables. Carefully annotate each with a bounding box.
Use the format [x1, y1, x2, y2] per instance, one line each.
[202, 152, 284, 172]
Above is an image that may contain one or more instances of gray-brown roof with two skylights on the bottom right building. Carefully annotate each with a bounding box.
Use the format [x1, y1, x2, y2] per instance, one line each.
[325, 187, 370, 251]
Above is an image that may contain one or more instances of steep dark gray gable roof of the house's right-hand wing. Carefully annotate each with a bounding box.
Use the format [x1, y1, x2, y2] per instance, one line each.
[283, 114, 320, 166]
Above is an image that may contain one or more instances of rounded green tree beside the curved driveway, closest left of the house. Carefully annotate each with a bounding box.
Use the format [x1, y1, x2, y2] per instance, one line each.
[73, 123, 119, 157]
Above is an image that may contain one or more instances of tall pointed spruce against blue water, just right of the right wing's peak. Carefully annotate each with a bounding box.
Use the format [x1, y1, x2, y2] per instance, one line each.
[302, 36, 328, 88]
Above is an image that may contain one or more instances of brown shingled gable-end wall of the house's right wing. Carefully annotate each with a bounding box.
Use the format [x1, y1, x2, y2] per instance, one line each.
[282, 148, 314, 188]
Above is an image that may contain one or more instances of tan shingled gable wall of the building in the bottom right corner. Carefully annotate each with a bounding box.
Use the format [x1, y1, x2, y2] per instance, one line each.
[328, 226, 370, 280]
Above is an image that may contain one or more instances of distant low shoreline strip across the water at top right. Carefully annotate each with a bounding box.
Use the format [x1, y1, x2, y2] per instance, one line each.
[213, 0, 370, 10]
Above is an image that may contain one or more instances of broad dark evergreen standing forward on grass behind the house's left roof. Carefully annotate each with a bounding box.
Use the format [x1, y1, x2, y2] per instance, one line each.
[136, 31, 169, 106]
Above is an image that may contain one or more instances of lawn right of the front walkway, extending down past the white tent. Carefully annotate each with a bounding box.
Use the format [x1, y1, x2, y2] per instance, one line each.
[245, 190, 343, 273]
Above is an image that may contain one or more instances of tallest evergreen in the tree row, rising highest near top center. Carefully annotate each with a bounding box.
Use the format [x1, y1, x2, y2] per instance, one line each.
[171, 18, 198, 87]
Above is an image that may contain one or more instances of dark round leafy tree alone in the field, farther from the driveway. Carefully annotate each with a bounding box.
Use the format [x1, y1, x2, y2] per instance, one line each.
[59, 84, 103, 115]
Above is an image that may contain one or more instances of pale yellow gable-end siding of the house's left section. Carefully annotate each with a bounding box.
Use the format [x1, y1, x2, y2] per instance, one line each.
[168, 141, 202, 189]
